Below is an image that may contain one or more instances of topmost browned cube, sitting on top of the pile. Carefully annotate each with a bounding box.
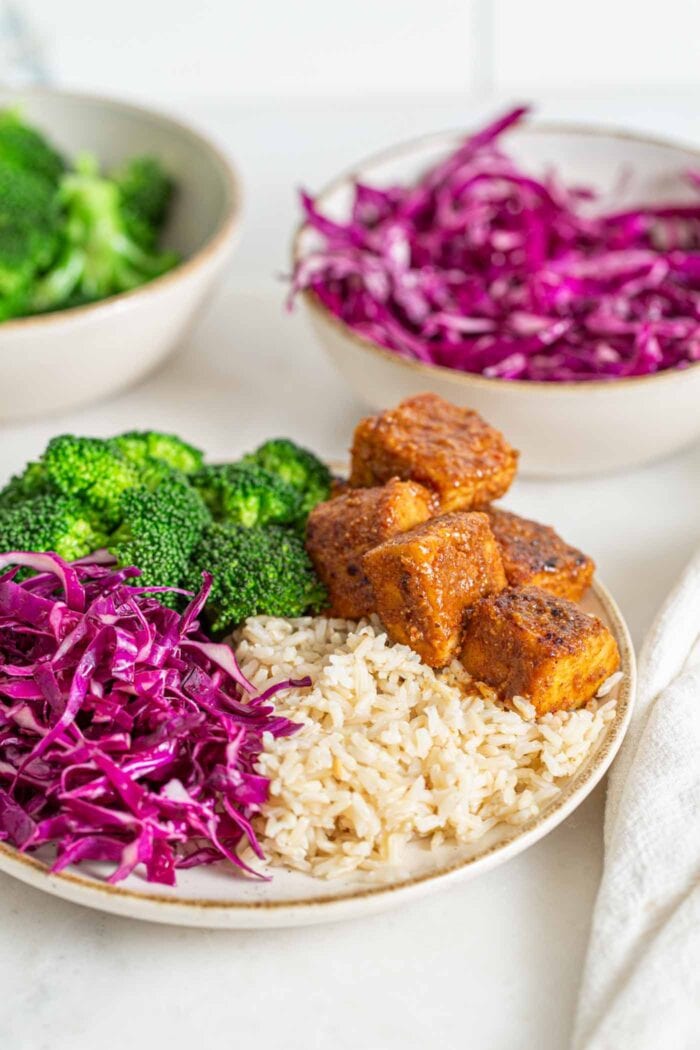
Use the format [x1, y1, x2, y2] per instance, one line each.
[351, 394, 517, 513]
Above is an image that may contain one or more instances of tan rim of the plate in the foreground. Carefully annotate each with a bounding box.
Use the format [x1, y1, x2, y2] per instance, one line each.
[0, 580, 636, 912]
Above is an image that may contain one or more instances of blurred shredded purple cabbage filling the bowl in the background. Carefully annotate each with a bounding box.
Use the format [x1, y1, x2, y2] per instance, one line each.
[293, 107, 700, 381]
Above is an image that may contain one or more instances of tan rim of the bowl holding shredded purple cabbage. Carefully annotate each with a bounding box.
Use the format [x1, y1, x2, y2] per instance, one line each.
[292, 121, 700, 392]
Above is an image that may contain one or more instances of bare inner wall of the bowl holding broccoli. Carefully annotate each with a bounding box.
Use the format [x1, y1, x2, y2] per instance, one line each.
[0, 90, 234, 257]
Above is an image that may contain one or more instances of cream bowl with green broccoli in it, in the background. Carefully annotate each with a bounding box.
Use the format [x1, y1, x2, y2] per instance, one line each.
[0, 89, 240, 420]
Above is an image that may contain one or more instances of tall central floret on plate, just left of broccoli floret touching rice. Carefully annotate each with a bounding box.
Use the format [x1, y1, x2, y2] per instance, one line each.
[107, 475, 211, 605]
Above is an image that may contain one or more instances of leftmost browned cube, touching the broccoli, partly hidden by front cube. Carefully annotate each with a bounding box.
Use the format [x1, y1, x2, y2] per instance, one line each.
[306, 478, 434, 620]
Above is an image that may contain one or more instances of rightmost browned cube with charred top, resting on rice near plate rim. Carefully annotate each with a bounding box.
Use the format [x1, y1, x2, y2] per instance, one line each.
[462, 587, 620, 715]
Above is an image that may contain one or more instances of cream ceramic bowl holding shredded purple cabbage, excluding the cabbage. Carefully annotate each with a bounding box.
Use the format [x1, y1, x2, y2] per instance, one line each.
[293, 125, 700, 477]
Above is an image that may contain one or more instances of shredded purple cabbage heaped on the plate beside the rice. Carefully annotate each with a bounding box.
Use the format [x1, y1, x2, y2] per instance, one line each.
[0, 551, 311, 885]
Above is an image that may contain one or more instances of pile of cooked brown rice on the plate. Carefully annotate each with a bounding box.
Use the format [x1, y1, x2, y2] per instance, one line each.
[235, 616, 615, 878]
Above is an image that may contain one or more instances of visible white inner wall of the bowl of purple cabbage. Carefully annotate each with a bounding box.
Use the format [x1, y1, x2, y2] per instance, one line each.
[295, 124, 700, 257]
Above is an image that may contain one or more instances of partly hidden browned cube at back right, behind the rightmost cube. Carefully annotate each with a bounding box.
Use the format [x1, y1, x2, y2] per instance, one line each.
[486, 507, 595, 602]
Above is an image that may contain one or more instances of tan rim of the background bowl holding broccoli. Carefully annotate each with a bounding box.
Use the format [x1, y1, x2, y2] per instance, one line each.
[0, 88, 242, 336]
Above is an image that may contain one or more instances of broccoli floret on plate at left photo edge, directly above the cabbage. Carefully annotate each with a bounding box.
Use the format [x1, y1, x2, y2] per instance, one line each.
[0, 492, 106, 562]
